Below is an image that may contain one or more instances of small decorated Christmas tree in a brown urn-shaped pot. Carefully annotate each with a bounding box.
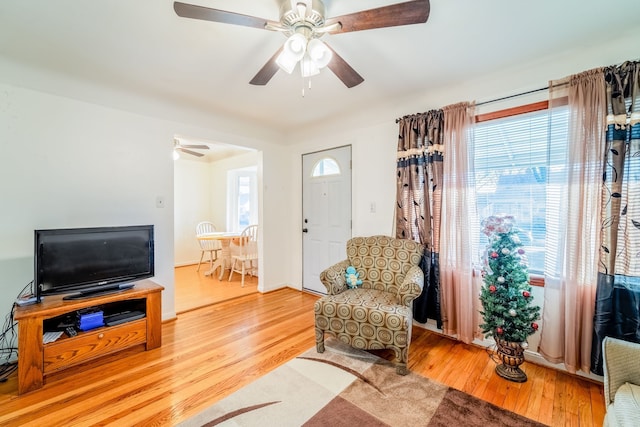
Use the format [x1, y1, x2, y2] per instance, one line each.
[480, 215, 540, 382]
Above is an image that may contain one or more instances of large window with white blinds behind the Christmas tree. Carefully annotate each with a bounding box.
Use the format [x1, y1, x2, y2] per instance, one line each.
[474, 103, 568, 275]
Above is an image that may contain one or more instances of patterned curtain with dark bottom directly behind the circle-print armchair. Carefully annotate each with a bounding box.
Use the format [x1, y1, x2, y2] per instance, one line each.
[396, 110, 443, 328]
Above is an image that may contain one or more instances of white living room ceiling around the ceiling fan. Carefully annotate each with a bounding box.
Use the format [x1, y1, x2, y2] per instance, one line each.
[0, 0, 640, 132]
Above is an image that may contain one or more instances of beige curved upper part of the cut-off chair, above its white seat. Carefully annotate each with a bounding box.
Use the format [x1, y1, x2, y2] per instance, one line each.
[602, 337, 640, 405]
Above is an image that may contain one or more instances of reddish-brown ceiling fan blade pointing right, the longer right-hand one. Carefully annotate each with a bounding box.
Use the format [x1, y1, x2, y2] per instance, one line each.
[326, 0, 430, 34]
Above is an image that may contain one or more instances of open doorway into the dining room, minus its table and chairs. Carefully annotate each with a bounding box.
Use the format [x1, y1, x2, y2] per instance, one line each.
[174, 137, 262, 314]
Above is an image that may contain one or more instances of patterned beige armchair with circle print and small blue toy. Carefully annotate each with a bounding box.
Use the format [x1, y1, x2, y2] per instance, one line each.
[314, 236, 424, 375]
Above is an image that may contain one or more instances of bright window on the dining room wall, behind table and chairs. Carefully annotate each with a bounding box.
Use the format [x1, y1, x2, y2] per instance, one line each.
[227, 167, 258, 232]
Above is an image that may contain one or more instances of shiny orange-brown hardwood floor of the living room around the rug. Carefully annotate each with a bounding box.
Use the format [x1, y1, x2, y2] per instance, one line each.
[0, 289, 604, 426]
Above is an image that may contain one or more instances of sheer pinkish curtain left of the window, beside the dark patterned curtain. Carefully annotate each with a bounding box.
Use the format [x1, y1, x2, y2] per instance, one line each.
[440, 102, 482, 343]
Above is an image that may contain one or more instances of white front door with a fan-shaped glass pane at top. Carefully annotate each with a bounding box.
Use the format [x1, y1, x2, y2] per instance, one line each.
[302, 146, 351, 294]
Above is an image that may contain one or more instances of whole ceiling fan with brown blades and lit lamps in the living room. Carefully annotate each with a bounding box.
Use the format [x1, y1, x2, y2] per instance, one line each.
[173, 0, 430, 88]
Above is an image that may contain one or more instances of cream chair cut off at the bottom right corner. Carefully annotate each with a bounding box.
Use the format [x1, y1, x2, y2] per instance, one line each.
[602, 337, 640, 427]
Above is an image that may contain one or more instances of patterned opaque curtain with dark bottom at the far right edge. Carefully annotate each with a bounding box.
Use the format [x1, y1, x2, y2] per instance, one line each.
[591, 62, 640, 375]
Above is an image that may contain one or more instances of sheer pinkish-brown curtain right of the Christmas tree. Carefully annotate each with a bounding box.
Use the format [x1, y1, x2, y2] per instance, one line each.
[538, 69, 606, 373]
